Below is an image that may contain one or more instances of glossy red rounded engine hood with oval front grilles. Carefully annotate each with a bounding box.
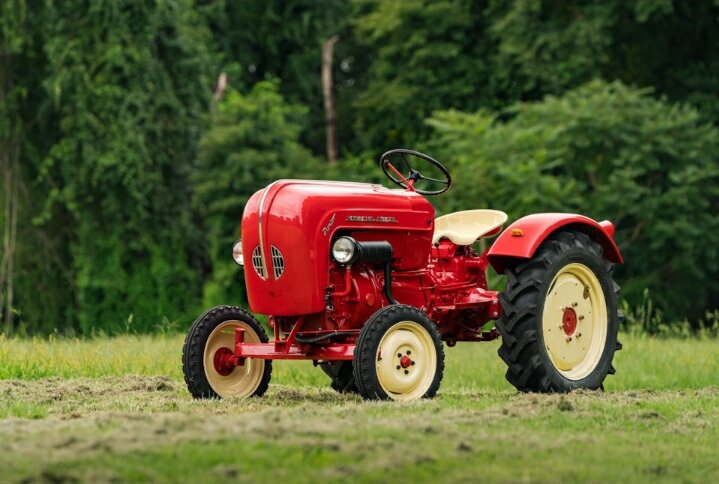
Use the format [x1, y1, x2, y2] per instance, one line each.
[242, 180, 434, 316]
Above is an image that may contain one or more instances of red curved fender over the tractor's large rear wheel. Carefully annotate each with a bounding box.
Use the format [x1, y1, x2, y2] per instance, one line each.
[487, 213, 623, 274]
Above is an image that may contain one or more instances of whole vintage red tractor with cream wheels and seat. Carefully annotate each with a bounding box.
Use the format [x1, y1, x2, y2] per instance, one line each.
[183, 150, 622, 400]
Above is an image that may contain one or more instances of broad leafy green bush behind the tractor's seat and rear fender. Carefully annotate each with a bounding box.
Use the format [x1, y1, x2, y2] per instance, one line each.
[429, 81, 719, 321]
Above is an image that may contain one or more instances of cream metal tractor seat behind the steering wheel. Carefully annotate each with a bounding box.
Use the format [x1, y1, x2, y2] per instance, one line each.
[432, 210, 507, 245]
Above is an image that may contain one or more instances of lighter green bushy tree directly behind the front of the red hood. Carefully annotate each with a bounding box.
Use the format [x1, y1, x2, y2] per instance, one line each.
[194, 81, 318, 306]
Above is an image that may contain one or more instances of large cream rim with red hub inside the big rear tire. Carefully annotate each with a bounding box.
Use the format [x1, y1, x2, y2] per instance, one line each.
[542, 263, 608, 380]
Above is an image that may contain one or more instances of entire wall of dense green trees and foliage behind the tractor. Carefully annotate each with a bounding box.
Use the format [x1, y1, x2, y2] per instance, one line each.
[0, 0, 719, 334]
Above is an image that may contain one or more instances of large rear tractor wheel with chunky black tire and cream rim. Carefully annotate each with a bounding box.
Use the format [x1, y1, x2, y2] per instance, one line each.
[497, 231, 621, 392]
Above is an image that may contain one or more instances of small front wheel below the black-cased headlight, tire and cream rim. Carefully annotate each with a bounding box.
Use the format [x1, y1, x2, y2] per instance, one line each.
[354, 304, 444, 401]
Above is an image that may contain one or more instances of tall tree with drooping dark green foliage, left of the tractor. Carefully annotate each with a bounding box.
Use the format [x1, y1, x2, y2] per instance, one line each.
[33, 0, 212, 332]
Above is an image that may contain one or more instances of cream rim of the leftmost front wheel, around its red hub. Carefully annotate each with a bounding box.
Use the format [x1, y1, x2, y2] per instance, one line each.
[203, 320, 265, 398]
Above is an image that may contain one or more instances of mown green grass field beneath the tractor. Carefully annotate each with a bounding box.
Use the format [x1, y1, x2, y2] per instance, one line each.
[0, 336, 719, 482]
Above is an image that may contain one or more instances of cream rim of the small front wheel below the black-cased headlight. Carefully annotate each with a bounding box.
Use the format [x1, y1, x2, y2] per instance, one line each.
[376, 321, 437, 400]
